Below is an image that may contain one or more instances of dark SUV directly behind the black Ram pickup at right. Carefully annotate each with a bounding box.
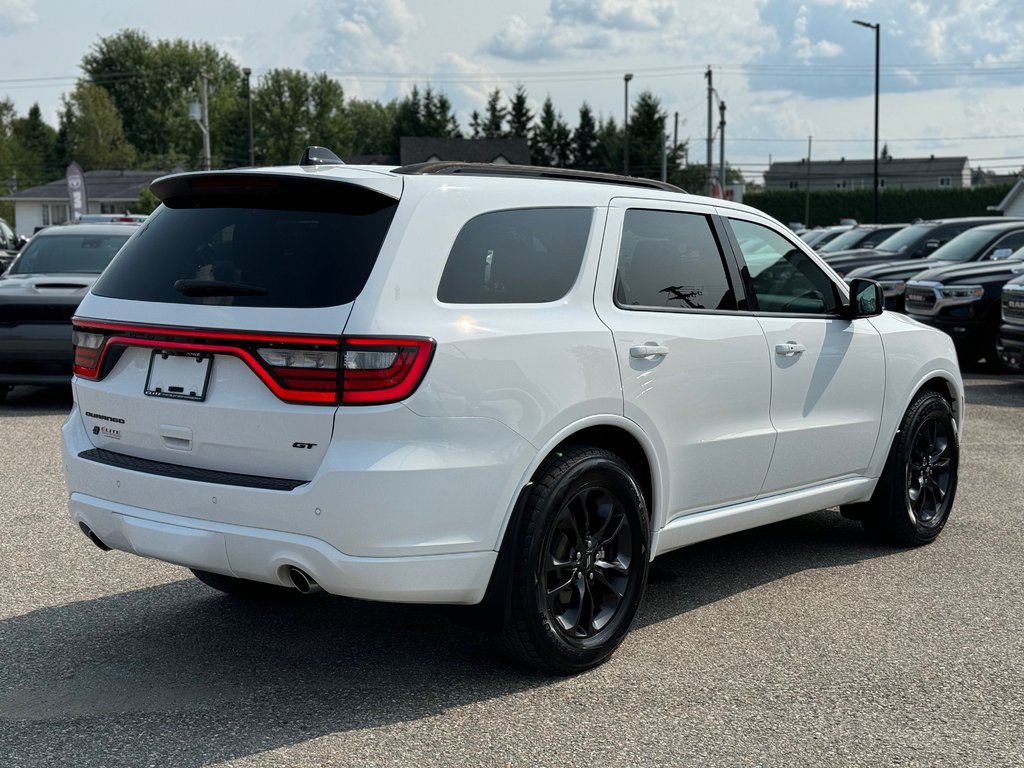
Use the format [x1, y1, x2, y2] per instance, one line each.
[846, 219, 1024, 312]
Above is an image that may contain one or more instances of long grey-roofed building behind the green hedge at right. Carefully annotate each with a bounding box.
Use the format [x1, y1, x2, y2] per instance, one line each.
[765, 155, 971, 191]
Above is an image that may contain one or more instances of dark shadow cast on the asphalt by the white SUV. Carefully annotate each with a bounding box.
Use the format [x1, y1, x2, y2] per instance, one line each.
[0, 512, 893, 768]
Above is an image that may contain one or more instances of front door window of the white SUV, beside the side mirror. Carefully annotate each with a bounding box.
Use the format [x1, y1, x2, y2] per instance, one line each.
[729, 219, 840, 314]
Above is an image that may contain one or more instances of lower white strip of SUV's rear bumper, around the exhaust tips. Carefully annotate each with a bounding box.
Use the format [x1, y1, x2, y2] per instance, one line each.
[69, 494, 498, 604]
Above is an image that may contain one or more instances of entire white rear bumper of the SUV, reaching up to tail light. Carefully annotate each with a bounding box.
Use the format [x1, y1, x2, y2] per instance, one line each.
[62, 406, 536, 604]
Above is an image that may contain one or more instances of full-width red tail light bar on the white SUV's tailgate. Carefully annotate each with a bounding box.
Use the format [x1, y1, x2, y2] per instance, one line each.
[72, 318, 434, 406]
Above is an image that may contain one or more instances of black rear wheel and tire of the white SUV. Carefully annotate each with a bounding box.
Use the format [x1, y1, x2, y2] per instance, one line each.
[504, 446, 650, 675]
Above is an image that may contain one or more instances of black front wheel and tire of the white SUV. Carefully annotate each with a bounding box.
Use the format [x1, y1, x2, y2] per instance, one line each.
[843, 391, 959, 547]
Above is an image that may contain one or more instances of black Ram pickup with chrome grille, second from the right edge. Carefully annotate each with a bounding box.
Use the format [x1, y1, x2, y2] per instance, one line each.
[906, 249, 1024, 371]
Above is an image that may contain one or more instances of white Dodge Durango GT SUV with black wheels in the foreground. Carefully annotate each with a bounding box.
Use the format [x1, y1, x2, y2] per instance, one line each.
[63, 151, 964, 673]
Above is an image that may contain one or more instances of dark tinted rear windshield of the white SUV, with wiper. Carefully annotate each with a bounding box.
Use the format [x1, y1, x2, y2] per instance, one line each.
[92, 189, 397, 308]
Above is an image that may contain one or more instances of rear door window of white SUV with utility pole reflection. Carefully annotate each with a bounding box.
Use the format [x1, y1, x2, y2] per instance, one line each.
[615, 210, 736, 309]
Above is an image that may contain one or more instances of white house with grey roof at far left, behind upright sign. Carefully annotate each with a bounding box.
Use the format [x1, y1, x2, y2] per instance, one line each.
[0, 171, 168, 236]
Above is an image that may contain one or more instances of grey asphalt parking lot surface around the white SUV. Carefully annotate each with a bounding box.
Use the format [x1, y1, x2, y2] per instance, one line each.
[0, 374, 1024, 768]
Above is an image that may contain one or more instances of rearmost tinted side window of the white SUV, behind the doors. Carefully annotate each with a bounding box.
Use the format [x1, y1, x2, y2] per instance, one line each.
[437, 208, 594, 304]
